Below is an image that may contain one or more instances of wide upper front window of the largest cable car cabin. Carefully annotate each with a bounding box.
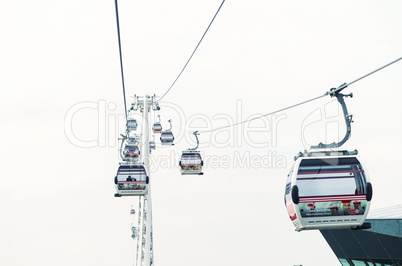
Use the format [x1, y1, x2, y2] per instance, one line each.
[296, 157, 366, 197]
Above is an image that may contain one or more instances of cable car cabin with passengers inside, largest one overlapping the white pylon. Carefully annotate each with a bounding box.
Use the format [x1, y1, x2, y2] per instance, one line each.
[114, 164, 149, 197]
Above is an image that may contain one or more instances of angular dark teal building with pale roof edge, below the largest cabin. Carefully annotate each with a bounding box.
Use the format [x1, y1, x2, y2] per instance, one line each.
[320, 205, 402, 266]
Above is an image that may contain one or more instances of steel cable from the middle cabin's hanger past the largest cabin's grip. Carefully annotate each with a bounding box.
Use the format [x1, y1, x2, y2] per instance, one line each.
[198, 57, 402, 133]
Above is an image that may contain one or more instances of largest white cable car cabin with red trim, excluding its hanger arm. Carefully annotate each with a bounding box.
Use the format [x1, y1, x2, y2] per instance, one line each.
[285, 151, 373, 231]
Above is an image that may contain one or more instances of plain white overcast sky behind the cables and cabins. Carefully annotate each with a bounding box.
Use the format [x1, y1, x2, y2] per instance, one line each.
[0, 0, 402, 266]
